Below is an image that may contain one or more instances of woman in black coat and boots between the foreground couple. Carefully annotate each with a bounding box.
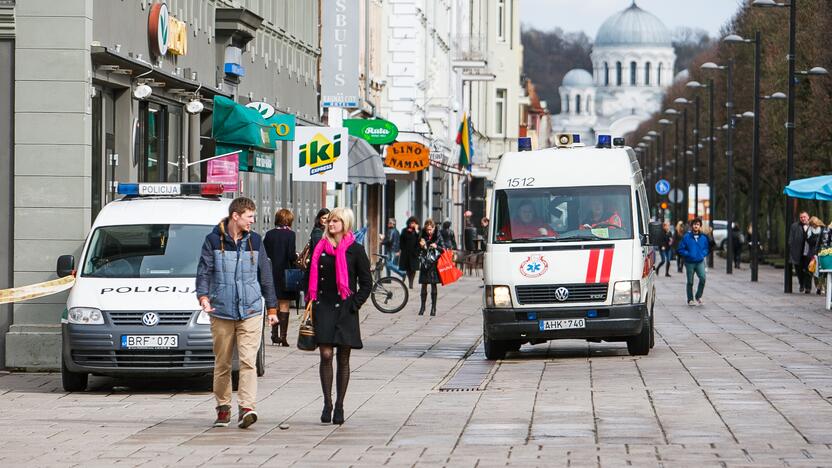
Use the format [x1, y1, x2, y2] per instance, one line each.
[263, 209, 298, 346]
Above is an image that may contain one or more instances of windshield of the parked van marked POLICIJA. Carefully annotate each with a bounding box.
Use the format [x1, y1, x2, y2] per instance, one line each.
[81, 224, 213, 278]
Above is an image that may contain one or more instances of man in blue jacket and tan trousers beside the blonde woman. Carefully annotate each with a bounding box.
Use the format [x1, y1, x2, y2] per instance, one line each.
[196, 197, 277, 428]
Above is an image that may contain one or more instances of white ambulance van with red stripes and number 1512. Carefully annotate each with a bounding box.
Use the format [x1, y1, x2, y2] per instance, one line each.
[483, 135, 661, 359]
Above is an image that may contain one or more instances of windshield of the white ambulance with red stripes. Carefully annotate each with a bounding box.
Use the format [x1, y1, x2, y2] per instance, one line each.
[494, 185, 633, 244]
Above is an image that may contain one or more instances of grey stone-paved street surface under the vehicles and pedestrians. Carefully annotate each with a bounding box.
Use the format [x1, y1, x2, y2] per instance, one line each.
[0, 260, 832, 467]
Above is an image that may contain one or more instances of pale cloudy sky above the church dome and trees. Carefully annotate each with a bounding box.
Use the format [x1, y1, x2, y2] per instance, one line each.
[520, 0, 742, 40]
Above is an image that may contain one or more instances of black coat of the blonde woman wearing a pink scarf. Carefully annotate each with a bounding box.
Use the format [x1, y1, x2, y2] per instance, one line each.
[312, 240, 373, 349]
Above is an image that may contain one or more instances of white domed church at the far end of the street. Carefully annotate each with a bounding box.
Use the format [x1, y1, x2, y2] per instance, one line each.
[554, 2, 676, 142]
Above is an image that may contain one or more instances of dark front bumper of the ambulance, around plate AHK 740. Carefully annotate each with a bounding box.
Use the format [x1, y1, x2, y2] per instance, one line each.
[482, 304, 648, 341]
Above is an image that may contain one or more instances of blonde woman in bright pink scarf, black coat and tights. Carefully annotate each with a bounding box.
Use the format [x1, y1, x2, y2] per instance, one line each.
[308, 208, 373, 424]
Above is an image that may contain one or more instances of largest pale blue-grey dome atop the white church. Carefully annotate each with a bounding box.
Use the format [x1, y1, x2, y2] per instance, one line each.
[595, 1, 673, 47]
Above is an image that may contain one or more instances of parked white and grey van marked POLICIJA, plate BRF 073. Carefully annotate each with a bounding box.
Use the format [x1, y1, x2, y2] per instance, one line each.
[57, 183, 265, 391]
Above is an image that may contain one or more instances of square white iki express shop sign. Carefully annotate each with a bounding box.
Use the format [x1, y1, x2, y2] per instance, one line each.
[292, 127, 350, 182]
